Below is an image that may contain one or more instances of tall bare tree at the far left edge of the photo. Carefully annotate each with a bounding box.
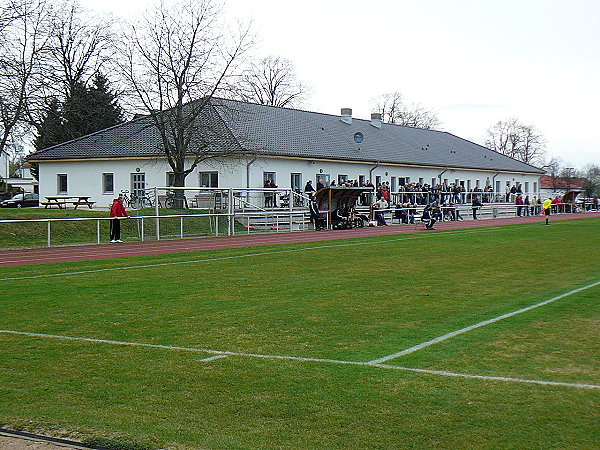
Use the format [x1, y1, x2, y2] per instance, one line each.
[0, 0, 52, 158]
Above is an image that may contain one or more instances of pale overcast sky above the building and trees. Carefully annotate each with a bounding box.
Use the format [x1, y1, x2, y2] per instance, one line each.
[83, 0, 600, 168]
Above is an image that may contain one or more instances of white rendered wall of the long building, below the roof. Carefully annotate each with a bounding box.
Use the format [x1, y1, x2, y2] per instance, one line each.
[39, 158, 539, 206]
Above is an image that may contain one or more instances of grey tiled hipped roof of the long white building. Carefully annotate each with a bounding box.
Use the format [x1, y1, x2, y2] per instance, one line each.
[32, 99, 543, 174]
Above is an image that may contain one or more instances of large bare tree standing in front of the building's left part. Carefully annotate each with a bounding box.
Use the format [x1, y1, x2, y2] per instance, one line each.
[121, 0, 251, 197]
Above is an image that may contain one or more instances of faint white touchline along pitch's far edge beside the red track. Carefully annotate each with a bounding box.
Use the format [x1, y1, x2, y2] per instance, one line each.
[0, 227, 510, 282]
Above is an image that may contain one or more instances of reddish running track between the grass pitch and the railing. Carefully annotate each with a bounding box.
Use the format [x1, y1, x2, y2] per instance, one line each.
[0, 213, 600, 266]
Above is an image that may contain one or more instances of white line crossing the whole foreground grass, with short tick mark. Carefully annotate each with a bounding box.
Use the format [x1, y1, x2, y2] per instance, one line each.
[0, 330, 600, 389]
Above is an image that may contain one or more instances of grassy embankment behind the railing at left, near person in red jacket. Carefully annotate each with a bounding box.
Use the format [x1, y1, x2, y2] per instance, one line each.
[0, 208, 232, 249]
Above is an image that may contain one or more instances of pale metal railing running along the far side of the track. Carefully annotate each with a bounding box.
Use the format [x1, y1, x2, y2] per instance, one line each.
[0, 195, 585, 248]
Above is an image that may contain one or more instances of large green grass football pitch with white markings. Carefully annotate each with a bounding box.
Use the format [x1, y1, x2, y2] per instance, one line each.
[0, 219, 600, 448]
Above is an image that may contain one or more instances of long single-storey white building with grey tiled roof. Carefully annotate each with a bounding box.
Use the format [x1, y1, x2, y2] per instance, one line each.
[30, 99, 543, 206]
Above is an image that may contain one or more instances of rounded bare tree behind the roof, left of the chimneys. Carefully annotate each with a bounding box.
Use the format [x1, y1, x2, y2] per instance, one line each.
[232, 56, 307, 107]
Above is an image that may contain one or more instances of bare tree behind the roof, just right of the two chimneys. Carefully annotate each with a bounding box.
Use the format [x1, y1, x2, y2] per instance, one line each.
[375, 91, 441, 130]
